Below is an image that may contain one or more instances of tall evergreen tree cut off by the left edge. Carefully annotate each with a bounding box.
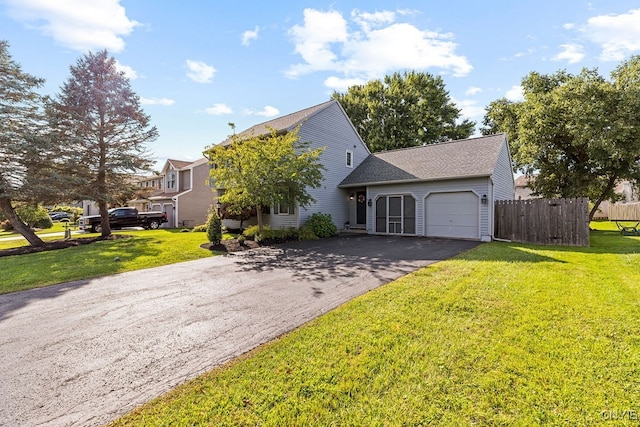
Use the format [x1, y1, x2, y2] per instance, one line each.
[0, 40, 56, 246]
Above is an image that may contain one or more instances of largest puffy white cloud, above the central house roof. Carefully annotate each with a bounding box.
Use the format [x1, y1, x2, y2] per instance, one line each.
[287, 9, 473, 83]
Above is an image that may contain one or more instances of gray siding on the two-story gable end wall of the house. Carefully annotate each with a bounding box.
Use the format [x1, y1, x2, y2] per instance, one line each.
[265, 103, 369, 229]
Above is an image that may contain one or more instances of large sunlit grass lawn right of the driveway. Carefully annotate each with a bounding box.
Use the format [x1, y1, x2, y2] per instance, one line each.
[113, 223, 640, 426]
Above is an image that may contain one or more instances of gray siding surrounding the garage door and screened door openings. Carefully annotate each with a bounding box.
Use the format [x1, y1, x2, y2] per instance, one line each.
[367, 177, 491, 240]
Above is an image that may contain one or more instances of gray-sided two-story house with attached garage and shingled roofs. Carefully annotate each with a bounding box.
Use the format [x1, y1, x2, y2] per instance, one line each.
[214, 100, 514, 241]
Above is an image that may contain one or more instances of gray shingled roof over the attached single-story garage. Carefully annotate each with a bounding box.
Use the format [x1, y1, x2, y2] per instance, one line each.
[340, 133, 506, 187]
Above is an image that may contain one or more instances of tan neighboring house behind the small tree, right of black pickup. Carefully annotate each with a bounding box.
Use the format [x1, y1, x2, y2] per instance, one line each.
[147, 157, 213, 228]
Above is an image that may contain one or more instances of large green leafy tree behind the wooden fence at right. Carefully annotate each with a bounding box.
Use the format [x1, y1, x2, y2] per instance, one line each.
[482, 56, 640, 218]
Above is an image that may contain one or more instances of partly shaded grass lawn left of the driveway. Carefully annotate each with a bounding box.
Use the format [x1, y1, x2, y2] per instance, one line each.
[0, 229, 217, 294]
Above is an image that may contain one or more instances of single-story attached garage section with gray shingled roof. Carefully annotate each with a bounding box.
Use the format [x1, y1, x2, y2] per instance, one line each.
[340, 134, 514, 242]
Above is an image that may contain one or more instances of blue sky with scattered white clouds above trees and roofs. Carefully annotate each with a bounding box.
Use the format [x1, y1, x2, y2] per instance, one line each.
[0, 0, 640, 169]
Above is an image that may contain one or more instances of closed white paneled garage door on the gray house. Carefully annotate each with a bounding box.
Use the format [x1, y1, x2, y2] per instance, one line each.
[425, 191, 480, 239]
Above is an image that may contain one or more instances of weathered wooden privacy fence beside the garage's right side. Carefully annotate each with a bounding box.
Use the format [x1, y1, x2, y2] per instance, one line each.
[494, 197, 589, 246]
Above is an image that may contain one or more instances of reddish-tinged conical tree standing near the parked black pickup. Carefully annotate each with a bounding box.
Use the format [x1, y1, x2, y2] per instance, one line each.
[49, 50, 158, 237]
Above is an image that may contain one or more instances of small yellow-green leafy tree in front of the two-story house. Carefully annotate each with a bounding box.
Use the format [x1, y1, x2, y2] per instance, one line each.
[205, 129, 324, 232]
